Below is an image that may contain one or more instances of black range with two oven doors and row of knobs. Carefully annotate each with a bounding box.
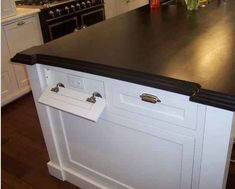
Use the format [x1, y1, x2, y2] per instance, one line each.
[16, 0, 105, 42]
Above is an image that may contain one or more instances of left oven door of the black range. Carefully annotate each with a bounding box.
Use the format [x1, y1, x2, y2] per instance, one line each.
[48, 16, 79, 41]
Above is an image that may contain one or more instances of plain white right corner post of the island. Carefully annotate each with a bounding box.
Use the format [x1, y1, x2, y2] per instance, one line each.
[200, 107, 235, 189]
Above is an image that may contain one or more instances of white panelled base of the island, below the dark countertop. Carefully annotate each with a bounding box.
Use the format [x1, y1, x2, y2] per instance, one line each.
[28, 64, 235, 189]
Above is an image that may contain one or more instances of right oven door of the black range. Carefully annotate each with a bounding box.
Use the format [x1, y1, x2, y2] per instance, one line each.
[81, 7, 105, 28]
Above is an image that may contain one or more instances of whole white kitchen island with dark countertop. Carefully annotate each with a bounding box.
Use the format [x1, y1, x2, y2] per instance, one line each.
[13, 1, 235, 189]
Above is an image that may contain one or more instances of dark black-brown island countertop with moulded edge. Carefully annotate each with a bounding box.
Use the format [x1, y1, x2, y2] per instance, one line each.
[12, 0, 235, 111]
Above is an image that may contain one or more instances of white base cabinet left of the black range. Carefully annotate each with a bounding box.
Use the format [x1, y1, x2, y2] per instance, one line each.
[1, 15, 42, 105]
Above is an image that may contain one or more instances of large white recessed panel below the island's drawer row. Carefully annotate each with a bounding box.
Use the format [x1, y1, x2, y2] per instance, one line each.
[56, 112, 195, 189]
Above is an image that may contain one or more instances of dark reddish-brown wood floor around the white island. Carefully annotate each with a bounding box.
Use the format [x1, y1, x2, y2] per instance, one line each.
[1, 94, 235, 189]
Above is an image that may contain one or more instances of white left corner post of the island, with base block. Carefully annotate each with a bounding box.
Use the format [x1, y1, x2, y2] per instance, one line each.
[27, 65, 65, 180]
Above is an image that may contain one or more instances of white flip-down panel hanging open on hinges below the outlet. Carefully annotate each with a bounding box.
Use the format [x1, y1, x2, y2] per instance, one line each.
[38, 85, 105, 122]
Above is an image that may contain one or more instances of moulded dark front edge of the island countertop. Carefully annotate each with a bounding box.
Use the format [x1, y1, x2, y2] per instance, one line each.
[11, 53, 235, 111]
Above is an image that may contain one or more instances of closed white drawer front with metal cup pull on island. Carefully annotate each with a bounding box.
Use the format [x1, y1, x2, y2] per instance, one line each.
[111, 81, 198, 130]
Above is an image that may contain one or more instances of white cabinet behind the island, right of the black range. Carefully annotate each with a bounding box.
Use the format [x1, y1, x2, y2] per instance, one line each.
[105, 0, 149, 19]
